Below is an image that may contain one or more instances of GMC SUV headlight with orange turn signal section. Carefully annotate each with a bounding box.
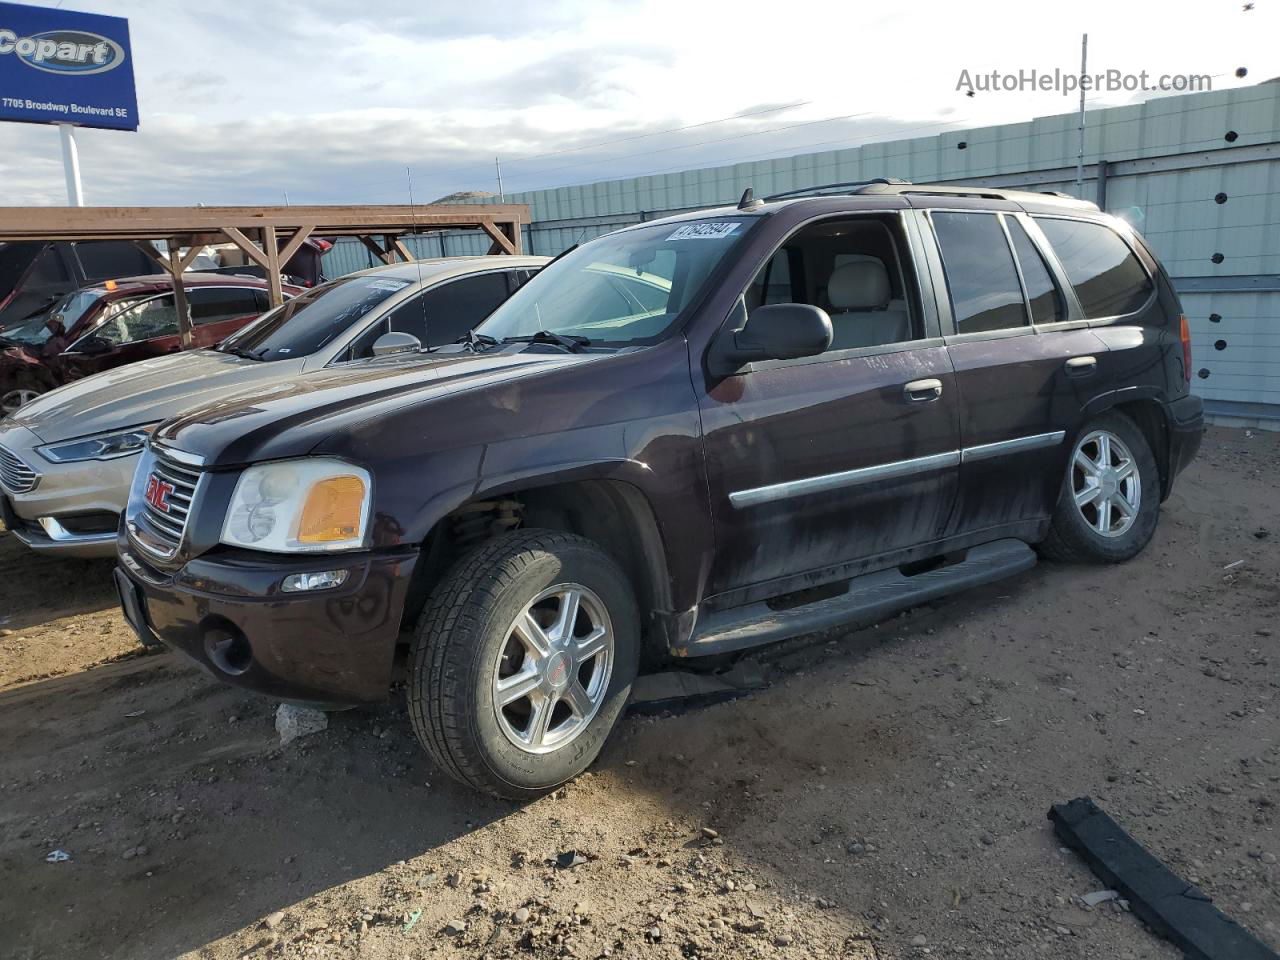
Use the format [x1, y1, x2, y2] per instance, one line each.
[223, 457, 371, 553]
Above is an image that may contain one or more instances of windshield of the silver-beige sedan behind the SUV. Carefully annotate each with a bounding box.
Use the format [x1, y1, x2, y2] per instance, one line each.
[218, 275, 410, 360]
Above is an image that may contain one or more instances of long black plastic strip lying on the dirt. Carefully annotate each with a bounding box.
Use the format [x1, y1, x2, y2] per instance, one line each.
[1048, 796, 1280, 960]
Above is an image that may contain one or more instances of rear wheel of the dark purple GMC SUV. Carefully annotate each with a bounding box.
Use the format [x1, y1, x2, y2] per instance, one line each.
[1041, 411, 1160, 563]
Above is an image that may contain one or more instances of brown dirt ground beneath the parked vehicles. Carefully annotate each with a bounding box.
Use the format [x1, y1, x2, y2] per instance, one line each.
[0, 429, 1280, 960]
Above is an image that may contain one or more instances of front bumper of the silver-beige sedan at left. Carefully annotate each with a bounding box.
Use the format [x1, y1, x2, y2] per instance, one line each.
[0, 425, 138, 557]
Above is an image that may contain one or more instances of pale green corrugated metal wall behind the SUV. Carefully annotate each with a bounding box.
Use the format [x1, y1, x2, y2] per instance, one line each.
[326, 83, 1280, 419]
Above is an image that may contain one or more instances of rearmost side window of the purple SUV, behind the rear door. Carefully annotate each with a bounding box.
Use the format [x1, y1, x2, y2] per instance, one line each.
[1036, 216, 1152, 320]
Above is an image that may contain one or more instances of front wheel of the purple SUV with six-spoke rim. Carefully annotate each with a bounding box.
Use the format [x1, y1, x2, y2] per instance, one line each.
[408, 530, 640, 799]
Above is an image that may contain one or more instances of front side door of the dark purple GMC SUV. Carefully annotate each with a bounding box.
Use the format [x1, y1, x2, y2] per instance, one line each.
[700, 214, 959, 603]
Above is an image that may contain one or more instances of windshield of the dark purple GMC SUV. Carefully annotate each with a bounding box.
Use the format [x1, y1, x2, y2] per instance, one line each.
[476, 216, 753, 347]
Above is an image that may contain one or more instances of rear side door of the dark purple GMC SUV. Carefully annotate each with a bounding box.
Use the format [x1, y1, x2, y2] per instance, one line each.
[918, 201, 1106, 539]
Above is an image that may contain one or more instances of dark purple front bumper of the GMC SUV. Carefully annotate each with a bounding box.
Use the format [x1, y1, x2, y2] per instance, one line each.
[116, 535, 417, 707]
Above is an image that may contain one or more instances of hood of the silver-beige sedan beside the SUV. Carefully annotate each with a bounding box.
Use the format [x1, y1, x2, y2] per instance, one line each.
[12, 349, 301, 443]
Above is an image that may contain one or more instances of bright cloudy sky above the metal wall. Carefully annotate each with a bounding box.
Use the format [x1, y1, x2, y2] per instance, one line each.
[0, 0, 1280, 205]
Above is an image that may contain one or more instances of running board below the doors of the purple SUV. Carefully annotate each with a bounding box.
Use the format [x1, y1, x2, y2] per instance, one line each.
[676, 540, 1036, 657]
